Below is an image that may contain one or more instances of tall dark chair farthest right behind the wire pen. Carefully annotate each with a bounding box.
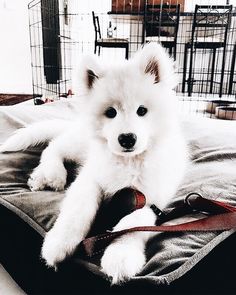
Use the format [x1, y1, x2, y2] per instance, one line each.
[182, 5, 232, 97]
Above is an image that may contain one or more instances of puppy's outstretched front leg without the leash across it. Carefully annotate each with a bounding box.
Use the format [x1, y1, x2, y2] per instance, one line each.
[42, 167, 101, 266]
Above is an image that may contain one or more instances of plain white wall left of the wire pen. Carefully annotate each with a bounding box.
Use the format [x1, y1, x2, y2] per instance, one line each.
[0, 0, 32, 93]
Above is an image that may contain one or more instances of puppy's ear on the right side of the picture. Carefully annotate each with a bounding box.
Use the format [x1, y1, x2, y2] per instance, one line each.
[134, 43, 177, 88]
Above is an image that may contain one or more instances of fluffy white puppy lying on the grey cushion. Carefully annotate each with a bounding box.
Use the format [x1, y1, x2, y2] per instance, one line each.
[1, 44, 187, 284]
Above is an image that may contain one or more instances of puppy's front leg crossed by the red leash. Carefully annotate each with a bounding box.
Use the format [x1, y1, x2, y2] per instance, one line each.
[101, 207, 156, 284]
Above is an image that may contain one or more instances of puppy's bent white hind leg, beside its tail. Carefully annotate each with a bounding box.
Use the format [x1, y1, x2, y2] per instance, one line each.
[28, 135, 82, 191]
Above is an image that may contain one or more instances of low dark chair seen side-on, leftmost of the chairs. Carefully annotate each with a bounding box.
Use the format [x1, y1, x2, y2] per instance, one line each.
[92, 11, 129, 59]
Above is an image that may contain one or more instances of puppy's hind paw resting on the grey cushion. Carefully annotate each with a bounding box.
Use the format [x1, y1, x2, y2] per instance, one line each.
[28, 164, 67, 191]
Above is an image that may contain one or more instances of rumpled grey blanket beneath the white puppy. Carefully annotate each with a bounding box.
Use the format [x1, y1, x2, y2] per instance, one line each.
[0, 100, 236, 285]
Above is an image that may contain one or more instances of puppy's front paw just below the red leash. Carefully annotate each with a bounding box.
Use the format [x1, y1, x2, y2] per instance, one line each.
[101, 241, 146, 284]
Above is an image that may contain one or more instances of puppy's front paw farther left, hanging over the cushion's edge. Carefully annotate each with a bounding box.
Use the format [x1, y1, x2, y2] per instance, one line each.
[41, 229, 74, 268]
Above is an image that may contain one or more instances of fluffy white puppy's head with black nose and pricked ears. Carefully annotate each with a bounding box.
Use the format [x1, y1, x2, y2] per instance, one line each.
[78, 44, 176, 157]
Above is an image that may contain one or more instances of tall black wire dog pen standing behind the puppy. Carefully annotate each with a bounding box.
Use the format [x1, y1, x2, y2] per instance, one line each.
[28, 0, 236, 119]
